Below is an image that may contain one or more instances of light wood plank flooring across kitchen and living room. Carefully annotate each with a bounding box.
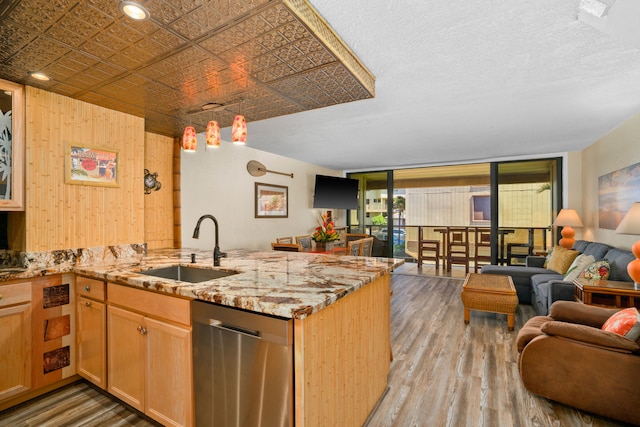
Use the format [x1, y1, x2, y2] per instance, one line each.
[0, 264, 624, 427]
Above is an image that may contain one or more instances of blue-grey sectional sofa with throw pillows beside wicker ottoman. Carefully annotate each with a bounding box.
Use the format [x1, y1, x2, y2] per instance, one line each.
[482, 240, 635, 316]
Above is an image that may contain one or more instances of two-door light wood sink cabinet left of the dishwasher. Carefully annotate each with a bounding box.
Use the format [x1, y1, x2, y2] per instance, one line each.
[107, 283, 194, 426]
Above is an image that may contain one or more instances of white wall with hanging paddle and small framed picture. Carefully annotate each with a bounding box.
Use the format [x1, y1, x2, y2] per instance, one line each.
[180, 134, 346, 251]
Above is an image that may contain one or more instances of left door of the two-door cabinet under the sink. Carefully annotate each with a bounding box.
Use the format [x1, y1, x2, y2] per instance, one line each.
[107, 306, 146, 411]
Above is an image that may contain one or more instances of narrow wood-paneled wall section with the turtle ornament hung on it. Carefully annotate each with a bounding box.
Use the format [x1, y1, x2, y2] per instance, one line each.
[144, 132, 174, 249]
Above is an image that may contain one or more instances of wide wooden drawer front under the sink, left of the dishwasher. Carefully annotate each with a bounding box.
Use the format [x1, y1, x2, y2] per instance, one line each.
[108, 283, 191, 326]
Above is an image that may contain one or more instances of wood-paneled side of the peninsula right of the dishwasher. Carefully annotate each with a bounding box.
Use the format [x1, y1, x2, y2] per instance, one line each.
[294, 274, 391, 427]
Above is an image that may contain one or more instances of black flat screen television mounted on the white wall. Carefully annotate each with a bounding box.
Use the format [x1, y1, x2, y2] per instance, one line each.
[313, 175, 358, 209]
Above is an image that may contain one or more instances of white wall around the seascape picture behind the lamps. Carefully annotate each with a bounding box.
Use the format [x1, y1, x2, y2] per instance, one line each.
[581, 114, 640, 249]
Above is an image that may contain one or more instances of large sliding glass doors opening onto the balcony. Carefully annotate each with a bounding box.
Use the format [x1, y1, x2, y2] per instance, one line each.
[347, 158, 562, 264]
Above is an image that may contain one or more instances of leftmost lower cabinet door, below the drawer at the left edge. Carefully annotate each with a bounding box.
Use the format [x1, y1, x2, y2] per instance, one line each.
[0, 304, 31, 401]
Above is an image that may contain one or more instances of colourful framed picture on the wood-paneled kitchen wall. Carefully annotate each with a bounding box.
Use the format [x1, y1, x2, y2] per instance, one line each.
[64, 143, 120, 187]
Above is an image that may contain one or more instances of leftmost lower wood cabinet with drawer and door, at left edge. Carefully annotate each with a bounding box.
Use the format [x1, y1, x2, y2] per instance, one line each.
[0, 282, 31, 401]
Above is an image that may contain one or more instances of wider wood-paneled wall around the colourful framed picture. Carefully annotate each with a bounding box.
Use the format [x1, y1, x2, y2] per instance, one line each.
[24, 87, 145, 251]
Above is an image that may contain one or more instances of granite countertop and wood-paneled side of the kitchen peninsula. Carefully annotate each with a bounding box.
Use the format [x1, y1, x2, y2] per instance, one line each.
[0, 249, 402, 426]
